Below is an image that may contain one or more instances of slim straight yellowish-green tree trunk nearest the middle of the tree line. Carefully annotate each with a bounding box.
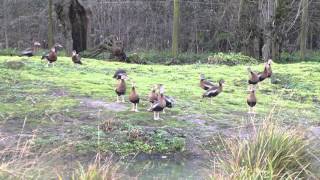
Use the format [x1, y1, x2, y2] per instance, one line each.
[172, 0, 180, 58]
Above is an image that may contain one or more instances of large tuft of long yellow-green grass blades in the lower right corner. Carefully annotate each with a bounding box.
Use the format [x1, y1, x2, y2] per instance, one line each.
[217, 122, 313, 180]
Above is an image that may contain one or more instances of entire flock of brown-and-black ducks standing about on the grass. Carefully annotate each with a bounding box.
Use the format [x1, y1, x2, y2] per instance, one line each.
[21, 43, 273, 120]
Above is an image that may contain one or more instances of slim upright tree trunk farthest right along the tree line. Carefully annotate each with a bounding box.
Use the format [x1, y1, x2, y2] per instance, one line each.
[300, 0, 309, 60]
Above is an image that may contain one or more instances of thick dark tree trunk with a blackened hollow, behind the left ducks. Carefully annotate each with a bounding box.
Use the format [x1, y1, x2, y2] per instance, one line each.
[55, 0, 92, 53]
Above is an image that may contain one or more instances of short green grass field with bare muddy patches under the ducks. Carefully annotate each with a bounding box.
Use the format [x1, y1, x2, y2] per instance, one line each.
[0, 56, 320, 179]
